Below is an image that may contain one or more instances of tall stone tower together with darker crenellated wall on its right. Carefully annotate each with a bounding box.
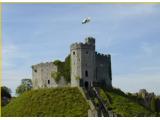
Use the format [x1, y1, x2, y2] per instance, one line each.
[70, 37, 112, 88]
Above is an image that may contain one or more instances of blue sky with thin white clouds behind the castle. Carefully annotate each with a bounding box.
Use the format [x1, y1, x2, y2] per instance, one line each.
[2, 3, 160, 95]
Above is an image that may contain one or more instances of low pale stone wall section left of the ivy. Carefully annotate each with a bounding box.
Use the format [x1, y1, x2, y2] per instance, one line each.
[32, 62, 67, 89]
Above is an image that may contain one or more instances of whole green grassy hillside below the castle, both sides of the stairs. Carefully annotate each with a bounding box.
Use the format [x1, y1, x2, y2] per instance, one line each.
[2, 87, 158, 117]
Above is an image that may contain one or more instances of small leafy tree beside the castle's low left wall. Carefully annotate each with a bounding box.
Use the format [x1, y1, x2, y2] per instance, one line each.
[16, 79, 32, 95]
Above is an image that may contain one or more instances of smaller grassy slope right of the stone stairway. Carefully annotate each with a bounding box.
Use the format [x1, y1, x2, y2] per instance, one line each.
[99, 90, 155, 117]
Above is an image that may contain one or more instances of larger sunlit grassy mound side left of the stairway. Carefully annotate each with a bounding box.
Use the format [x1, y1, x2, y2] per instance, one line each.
[2, 88, 89, 117]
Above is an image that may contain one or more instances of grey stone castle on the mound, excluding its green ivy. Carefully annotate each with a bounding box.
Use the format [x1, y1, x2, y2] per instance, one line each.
[32, 37, 112, 89]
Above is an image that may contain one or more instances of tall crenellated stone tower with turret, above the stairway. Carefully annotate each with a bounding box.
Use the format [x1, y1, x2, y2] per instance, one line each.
[70, 37, 95, 88]
